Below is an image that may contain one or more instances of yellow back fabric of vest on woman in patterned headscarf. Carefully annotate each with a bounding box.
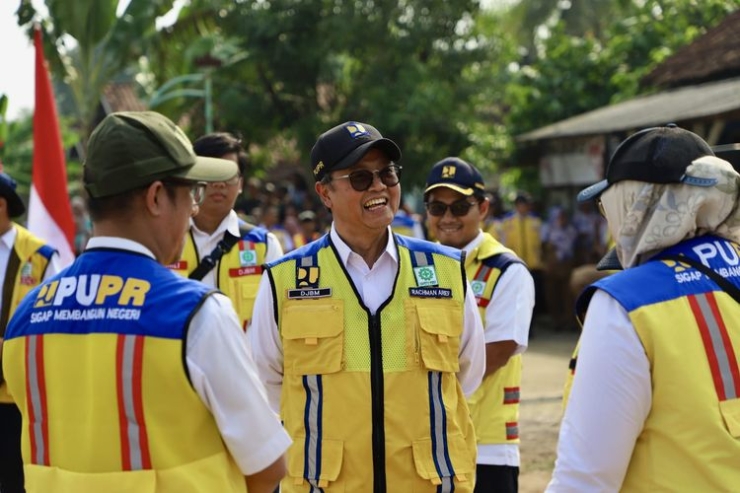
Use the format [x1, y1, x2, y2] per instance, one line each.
[622, 292, 740, 492]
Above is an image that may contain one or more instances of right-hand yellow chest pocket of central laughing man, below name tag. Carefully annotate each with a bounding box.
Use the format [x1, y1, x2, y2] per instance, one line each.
[416, 301, 462, 373]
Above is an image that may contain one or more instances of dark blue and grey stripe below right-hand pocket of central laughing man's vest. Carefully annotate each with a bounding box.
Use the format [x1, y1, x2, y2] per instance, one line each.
[429, 371, 455, 493]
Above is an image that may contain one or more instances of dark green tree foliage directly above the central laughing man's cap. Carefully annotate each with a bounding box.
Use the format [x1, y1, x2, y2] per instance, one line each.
[152, 0, 487, 183]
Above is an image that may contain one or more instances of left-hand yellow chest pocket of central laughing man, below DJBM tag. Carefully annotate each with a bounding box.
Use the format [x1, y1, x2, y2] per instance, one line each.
[280, 299, 344, 375]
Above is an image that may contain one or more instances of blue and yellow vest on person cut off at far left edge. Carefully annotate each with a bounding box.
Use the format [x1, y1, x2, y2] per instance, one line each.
[0, 223, 56, 403]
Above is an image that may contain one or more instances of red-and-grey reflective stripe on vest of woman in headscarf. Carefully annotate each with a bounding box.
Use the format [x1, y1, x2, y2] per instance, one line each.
[688, 292, 740, 401]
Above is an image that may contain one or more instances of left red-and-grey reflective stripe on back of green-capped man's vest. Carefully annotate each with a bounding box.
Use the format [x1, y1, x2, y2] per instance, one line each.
[26, 335, 49, 466]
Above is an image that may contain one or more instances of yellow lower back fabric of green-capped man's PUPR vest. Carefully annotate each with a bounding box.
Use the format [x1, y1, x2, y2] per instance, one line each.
[4, 334, 246, 493]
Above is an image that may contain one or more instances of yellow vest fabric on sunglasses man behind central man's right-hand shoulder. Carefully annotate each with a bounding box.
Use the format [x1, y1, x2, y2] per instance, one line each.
[465, 233, 522, 444]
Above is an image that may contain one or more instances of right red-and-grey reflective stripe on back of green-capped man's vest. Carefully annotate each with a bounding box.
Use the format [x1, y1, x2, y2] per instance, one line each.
[116, 334, 152, 471]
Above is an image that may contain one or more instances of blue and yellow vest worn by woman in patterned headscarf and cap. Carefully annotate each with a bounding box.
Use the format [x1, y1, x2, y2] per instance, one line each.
[580, 235, 740, 492]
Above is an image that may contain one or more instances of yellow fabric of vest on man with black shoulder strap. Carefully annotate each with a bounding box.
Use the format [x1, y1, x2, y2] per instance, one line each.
[172, 234, 267, 330]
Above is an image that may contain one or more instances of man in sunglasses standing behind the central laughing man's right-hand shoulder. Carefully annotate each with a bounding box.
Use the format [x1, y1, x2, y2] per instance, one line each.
[424, 157, 534, 493]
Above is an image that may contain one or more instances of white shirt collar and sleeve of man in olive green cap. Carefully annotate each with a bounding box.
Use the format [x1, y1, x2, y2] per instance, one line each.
[79, 236, 291, 475]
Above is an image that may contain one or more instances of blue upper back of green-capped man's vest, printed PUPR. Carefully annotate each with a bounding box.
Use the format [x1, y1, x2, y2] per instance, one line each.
[5, 249, 212, 339]
